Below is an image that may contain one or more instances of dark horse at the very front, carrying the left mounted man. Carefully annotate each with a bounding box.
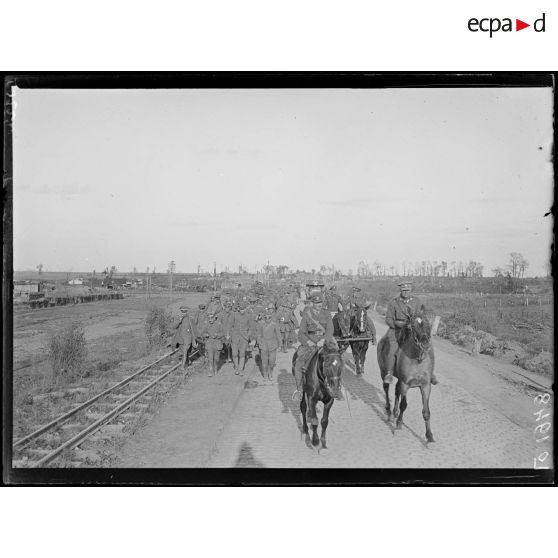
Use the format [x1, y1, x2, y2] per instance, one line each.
[293, 347, 343, 449]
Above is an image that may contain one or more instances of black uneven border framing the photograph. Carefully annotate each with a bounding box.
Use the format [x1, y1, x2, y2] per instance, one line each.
[2, 72, 557, 486]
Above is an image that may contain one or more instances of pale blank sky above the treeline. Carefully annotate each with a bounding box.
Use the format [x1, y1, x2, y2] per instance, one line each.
[13, 88, 553, 275]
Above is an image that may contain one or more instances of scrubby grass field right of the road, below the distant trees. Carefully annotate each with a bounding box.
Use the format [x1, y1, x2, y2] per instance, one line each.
[338, 278, 554, 376]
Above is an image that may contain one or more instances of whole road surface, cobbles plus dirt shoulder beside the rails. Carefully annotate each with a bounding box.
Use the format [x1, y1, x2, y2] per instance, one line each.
[115, 315, 552, 469]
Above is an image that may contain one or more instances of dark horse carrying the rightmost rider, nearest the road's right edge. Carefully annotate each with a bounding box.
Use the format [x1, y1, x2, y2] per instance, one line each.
[378, 313, 440, 442]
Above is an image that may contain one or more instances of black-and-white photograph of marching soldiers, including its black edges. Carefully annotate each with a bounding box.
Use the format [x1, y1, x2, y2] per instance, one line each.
[4, 73, 555, 484]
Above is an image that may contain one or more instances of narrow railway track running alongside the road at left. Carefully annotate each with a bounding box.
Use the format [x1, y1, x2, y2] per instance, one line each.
[12, 349, 198, 468]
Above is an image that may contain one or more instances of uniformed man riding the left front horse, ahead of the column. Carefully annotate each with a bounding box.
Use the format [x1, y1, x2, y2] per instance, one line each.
[293, 294, 339, 401]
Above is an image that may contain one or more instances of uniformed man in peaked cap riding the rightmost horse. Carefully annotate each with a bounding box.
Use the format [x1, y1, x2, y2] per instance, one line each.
[384, 281, 438, 385]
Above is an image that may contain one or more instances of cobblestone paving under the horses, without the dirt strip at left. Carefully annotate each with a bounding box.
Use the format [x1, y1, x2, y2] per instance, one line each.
[208, 321, 544, 468]
